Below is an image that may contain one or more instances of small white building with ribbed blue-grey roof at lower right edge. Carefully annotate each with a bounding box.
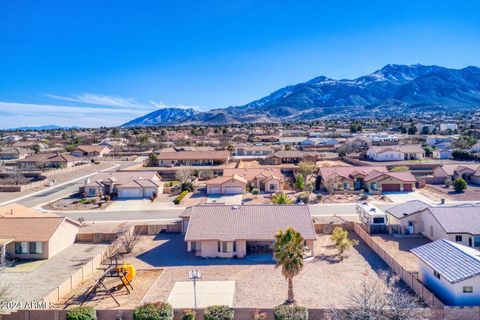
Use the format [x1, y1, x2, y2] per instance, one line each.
[410, 239, 480, 306]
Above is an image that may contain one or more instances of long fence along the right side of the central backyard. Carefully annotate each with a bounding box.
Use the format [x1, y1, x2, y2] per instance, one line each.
[353, 223, 480, 320]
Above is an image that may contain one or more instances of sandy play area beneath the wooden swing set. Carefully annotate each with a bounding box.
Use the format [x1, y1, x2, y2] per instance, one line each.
[57, 269, 162, 309]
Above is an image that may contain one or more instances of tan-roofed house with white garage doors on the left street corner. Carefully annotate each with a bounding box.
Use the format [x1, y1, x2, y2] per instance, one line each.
[79, 171, 163, 199]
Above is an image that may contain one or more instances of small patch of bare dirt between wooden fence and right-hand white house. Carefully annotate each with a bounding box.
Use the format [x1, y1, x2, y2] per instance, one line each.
[373, 235, 430, 272]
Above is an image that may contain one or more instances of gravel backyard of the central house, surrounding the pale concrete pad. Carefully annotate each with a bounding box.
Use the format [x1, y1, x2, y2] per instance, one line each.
[134, 235, 398, 308]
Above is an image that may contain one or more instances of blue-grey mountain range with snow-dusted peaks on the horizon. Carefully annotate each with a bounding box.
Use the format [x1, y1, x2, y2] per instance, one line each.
[123, 64, 480, 127]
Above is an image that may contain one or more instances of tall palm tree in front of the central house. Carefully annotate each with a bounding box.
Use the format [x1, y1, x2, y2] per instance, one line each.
[273, 227, 304, 303]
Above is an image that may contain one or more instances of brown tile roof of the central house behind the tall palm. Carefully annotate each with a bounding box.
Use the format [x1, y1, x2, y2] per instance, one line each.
[182, 205, 316, 241]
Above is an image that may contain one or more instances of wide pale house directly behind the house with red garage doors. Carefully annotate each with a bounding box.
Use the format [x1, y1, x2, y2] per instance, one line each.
[367, 144, 425, 161]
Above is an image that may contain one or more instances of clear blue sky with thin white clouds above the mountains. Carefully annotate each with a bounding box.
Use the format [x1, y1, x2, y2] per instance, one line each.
[0, 0, 480, 128]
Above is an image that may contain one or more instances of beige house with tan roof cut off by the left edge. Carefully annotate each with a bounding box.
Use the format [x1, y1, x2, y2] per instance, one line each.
[0, 204, 80, 260]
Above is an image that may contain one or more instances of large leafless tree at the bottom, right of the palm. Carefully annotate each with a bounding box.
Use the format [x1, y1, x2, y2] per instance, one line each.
[329, 272, 427, 320]
